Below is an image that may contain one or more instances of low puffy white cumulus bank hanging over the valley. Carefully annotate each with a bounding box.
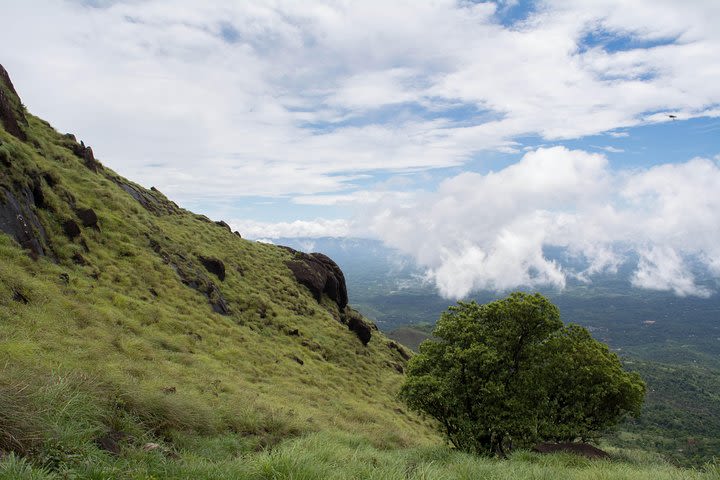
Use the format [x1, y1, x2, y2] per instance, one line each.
[365, 147, 720, 298]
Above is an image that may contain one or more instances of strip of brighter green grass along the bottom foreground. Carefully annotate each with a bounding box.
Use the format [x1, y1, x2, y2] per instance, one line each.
[0, 431, 720, 480]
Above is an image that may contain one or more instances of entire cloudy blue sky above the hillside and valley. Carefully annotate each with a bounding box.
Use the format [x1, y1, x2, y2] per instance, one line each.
[0, 0, 720, 298]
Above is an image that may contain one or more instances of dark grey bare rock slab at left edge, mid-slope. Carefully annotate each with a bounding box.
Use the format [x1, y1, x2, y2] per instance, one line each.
[0, 187, 47, 258]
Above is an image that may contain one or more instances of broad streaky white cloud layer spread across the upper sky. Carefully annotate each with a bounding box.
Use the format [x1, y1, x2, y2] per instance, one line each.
[0, 0, 720, 201]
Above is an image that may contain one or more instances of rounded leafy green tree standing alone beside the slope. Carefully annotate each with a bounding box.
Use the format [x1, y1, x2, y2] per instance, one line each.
[401, 292, 645, 454]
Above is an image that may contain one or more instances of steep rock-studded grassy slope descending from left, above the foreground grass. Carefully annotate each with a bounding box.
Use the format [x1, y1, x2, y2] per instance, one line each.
[0, 67, 434, 464]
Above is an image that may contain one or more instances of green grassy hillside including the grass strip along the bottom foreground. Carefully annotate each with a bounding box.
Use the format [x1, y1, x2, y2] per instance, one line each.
[0, 66, 717, 479]
